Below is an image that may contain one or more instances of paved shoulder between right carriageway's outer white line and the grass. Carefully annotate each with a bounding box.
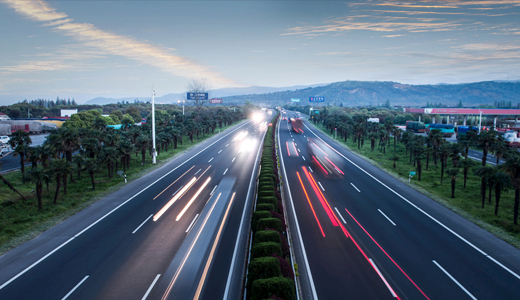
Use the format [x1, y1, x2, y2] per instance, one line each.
[302, 120, 520, 274]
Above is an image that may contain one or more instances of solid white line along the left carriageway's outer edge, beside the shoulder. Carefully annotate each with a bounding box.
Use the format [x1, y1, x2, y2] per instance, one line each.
[0, 121, 250, 290]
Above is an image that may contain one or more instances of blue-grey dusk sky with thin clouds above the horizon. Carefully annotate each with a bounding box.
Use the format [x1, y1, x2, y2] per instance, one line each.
[0, 0, 520, 105]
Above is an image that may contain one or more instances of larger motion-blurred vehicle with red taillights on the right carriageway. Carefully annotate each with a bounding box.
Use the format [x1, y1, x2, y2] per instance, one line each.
[307, 137, 345, 178]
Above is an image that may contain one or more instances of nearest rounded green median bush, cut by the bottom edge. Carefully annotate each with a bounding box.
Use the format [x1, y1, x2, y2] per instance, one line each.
[251, 277, 296, 300]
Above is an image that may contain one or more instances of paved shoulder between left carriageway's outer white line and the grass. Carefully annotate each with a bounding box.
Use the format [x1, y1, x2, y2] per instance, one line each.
[0, 123, 252, 294]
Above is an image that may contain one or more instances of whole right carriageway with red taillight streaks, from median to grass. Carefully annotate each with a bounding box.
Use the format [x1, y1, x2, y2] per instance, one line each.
[277, 113, 520, 299]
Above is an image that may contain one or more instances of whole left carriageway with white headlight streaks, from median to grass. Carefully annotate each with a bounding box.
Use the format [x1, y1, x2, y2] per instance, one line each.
[0, 113, 272, 299]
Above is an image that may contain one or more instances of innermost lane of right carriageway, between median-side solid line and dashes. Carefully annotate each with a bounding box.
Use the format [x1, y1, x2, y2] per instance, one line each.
[280, 126, 393, 299]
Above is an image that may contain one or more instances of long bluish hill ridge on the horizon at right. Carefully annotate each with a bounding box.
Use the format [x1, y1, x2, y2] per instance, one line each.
[224, 80, 520, 106]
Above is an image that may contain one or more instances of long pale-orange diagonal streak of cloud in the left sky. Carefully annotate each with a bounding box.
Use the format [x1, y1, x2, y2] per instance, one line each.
[0, 0, 238, 87]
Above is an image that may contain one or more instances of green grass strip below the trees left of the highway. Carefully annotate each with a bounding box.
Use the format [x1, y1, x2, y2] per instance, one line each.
[0, 122, 243, 253]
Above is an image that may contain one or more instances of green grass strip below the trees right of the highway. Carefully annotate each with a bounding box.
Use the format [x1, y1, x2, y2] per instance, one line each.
[310, 125, 520, 248]
